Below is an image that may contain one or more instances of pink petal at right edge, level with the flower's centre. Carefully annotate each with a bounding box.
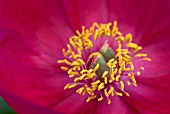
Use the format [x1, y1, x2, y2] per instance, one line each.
[134, 40, 170, 78]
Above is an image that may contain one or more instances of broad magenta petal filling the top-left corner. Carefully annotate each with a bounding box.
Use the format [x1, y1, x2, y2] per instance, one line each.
[0, 0, 73, 51]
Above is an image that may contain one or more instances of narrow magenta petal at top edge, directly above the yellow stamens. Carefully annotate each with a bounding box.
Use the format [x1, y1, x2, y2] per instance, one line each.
[63, 0, 108, 30]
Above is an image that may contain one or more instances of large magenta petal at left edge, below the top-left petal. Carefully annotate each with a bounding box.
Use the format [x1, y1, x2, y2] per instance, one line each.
[0, 30, 72, 110]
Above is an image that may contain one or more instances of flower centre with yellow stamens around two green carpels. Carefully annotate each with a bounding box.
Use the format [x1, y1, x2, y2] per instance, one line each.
[58, 21, 151, 104]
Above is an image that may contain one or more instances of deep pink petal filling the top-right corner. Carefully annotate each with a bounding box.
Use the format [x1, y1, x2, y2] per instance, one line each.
[108, 0, 170, 45]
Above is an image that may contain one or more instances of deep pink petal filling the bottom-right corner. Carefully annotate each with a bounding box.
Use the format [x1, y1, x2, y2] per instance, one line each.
[124, 75, 170, 114]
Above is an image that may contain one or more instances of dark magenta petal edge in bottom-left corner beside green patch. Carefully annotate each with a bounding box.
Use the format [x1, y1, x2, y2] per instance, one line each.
[0, 92, 62, 114]
